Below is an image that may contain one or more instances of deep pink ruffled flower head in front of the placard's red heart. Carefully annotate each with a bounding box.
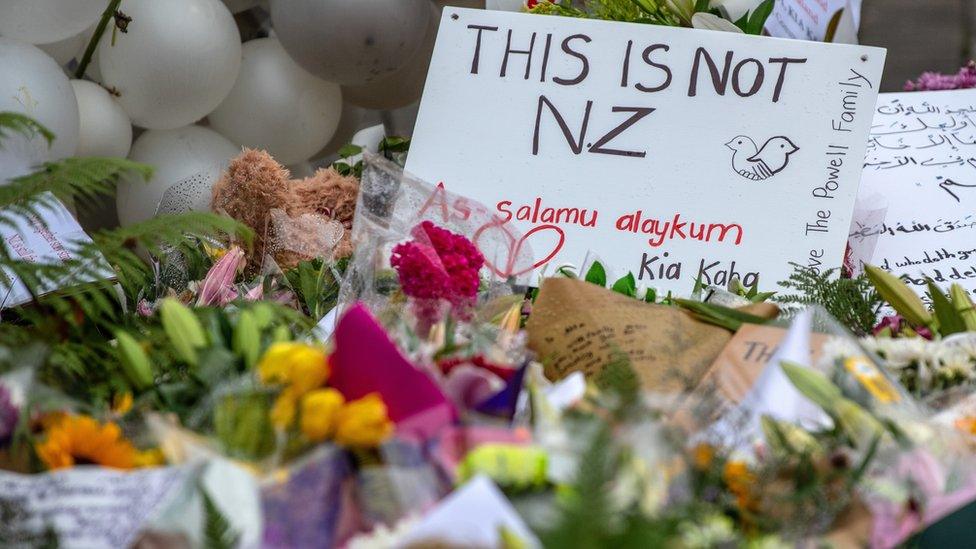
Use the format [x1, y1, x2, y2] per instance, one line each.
[390, 221, 485, 312]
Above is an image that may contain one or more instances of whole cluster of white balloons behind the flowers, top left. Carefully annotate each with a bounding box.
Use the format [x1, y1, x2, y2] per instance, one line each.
[0, 0, 443, 225]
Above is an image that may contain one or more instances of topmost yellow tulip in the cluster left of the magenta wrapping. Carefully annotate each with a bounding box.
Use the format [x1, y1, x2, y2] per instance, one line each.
[258, 342, 329, 396]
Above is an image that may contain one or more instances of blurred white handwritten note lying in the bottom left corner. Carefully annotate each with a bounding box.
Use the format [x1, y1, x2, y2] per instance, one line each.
[0, 467, 189, 549]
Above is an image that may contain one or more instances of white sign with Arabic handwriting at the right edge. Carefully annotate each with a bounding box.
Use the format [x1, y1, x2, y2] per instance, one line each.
[851, 90, 976, 300]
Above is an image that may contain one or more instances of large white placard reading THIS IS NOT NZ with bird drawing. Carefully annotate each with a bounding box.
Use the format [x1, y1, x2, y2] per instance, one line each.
[407, 8, 885, 293]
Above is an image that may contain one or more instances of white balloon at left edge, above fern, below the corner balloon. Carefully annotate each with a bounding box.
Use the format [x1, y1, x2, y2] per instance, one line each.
[0, 38, 78, 160]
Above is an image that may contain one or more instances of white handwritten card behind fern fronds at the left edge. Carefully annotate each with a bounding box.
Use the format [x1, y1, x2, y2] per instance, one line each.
[0, 196, 112, 308]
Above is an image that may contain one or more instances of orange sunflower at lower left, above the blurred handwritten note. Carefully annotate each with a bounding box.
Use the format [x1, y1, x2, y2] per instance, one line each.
[35, 415, 137, 469]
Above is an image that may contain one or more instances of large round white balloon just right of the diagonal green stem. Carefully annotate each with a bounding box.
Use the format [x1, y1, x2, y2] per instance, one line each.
[98, 0, 241, 130]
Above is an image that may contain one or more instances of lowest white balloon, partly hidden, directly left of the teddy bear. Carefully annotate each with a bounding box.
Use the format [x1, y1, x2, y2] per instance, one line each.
[116, 126, 241, 226]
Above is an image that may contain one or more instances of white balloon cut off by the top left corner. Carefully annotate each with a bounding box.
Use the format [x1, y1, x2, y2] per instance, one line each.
[0, 0, 108, 44]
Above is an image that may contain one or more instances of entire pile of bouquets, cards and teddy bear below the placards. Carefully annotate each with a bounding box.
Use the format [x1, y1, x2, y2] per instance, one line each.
[0, 82, 976, 548]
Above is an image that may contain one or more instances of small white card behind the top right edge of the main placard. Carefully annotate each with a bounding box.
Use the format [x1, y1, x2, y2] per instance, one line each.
[766, 0, 861, 43]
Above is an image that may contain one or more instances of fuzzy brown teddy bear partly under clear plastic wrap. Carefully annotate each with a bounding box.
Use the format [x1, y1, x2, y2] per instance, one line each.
[211, 149, 359, 269]
